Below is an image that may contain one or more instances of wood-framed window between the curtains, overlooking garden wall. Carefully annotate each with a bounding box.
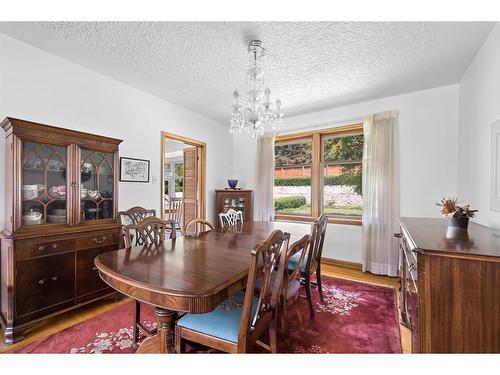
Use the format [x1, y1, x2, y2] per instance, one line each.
[274, 124, 363, 224]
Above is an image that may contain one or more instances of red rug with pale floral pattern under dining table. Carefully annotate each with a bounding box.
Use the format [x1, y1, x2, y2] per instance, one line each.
[16, 276, 401, 353]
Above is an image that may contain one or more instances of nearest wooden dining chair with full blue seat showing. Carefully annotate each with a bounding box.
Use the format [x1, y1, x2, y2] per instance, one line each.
[175, 230, 290, 353]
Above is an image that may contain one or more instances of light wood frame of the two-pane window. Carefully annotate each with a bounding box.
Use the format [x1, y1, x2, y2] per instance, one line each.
[273, 123, 363, 225]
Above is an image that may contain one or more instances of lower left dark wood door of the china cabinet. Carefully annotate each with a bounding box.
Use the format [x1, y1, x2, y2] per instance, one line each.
[16, 252, 75, 317]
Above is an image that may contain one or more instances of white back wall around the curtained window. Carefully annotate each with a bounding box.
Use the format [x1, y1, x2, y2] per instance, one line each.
[233, 85, 458, 262]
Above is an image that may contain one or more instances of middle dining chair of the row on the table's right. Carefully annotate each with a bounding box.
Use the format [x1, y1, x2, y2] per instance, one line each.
[279, 234, 311, 352]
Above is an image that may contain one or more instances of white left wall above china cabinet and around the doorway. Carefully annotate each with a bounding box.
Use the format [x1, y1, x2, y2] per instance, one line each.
[0, 34, 233, 230]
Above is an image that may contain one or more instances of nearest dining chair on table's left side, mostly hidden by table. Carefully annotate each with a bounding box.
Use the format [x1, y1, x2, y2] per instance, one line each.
[122, 216, 176, 343]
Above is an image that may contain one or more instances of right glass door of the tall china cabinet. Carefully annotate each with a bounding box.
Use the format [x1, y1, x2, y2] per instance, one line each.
[80, 149, 114, 222]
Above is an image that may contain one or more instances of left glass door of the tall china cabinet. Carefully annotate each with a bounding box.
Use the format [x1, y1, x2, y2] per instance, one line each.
[21, 141, 68, 226]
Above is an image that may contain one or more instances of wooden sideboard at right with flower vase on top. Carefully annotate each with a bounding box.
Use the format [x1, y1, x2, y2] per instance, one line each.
[396, 218, 500, 353]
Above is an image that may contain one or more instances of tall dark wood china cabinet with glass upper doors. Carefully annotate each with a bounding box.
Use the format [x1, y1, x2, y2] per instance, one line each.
[0, 118, 121, 344]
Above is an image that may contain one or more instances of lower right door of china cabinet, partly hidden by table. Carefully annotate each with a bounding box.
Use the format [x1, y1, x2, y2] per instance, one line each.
[76, 245, 117, 297]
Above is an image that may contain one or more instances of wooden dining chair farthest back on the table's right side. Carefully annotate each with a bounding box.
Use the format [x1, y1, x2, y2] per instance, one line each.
[288, 214, 328, 318]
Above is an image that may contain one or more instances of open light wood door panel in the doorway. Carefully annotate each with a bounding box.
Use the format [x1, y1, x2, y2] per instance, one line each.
[182, 147, 198, 234]
